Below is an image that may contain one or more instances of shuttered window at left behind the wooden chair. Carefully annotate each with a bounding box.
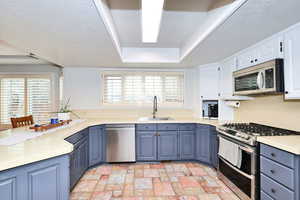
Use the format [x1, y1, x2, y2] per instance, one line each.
[0, 75, 51, 124]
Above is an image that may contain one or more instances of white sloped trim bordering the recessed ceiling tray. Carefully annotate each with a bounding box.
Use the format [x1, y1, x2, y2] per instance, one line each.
[93, 0, 248, 63]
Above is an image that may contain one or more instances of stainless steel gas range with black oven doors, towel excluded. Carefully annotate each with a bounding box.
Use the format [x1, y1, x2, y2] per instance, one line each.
[217, 123, 299, 200]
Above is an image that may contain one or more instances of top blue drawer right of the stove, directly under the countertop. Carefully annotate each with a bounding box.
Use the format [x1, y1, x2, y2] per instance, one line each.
[260, 144, 295, 168]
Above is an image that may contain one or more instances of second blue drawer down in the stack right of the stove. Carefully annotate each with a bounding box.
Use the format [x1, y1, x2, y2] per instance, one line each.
[260, 156, 294, 190]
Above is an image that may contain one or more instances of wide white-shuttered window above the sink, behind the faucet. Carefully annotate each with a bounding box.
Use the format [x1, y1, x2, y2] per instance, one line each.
[102, 72, 184, 105]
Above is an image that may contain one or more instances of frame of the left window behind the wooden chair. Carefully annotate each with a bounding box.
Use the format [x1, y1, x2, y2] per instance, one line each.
[0, 73, 54, 123]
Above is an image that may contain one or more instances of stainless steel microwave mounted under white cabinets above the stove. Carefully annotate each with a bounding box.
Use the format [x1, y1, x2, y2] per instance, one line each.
[233, 59, 284, 95]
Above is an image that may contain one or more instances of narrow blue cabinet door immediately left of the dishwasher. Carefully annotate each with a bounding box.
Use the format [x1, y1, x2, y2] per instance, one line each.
[89, 126, 105, 166]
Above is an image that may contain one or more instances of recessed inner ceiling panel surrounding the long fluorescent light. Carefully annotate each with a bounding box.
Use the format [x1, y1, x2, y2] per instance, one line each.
[111, 10, 207, 48]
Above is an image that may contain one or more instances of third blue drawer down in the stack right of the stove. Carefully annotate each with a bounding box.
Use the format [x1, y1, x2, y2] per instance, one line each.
[260, 174, 294, 200]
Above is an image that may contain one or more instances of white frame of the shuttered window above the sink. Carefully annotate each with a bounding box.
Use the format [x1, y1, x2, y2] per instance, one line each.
[100, 71, 186, 108]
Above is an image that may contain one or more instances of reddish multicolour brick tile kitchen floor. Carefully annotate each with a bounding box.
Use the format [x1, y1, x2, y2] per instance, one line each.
[70, 162, 239, 200]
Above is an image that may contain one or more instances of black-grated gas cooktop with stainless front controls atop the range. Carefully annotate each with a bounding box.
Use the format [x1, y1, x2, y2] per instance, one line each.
[217, 123, 300, 146]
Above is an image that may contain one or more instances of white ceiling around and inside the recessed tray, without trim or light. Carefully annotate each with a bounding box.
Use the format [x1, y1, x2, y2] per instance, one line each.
[0, 0, 300, 67]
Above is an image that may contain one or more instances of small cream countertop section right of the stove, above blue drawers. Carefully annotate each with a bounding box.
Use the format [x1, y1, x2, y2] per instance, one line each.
[257, 135, 300, 155]
